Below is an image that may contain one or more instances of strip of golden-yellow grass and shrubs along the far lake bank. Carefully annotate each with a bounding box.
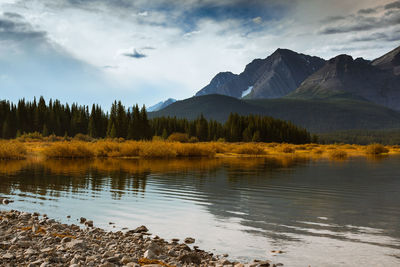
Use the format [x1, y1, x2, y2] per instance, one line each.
[0, 139, 400, 159]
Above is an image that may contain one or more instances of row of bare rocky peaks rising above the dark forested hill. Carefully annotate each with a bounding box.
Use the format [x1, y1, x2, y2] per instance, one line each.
[196, 47, 400, 110]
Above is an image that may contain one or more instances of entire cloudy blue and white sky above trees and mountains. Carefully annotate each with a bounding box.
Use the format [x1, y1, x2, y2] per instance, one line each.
[0, 0, 400, 106]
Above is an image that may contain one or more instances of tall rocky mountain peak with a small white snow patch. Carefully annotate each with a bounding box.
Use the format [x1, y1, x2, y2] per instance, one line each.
[196, 49, 325, 99]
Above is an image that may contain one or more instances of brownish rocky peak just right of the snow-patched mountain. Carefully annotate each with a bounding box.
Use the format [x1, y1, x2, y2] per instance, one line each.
[288, 55, 400, 110]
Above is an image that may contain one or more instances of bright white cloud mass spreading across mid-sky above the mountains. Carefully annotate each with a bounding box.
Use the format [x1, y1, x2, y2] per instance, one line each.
[0, 0, 392, 107]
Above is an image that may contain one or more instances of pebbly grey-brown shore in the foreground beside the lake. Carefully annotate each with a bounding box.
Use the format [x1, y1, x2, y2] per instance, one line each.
[0, 210, 282, 267]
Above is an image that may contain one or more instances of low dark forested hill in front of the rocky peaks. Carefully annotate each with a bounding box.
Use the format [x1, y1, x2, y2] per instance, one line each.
[149, 95, 400, 133]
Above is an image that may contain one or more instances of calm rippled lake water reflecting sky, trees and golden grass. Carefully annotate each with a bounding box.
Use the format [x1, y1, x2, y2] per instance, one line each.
[0, 157, 400, 266]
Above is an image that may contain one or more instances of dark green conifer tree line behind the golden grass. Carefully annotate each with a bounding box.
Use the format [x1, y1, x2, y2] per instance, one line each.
[0, 97, 315, 144]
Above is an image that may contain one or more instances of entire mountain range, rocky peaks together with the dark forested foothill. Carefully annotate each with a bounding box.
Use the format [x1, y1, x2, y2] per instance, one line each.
[150, 47, 400, 132]
